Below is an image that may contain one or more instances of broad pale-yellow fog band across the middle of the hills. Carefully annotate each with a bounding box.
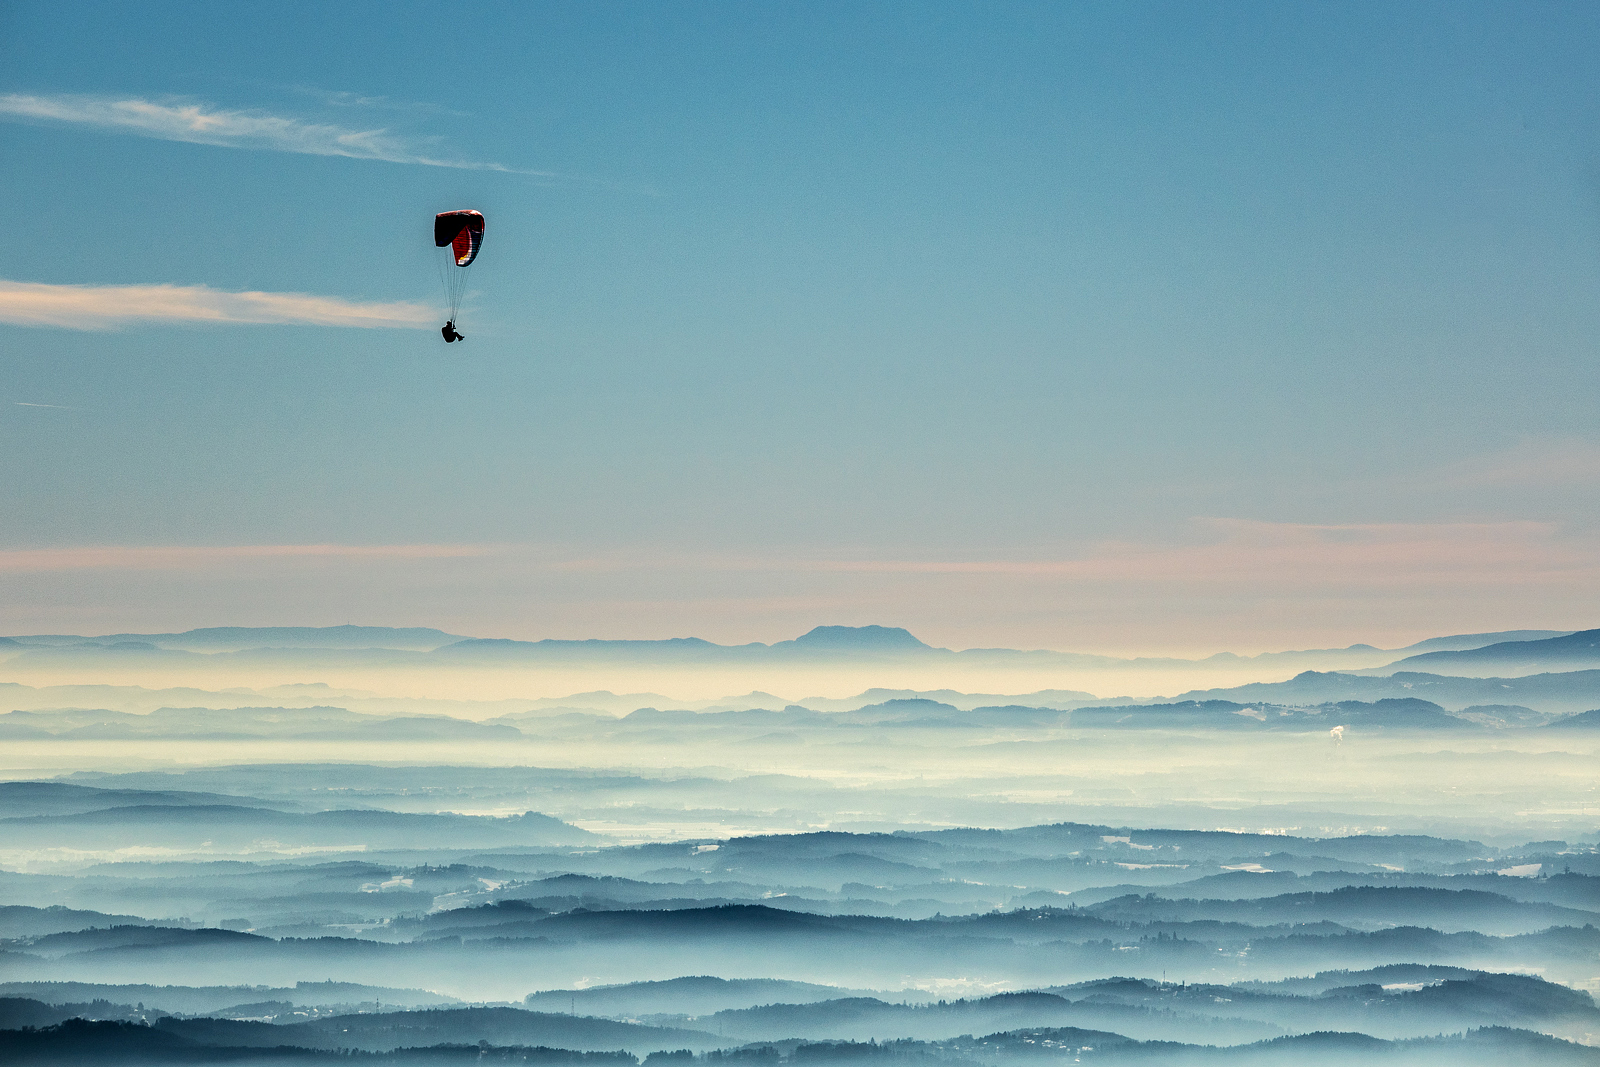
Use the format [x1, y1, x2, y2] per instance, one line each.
[0, 723, 1600, 862]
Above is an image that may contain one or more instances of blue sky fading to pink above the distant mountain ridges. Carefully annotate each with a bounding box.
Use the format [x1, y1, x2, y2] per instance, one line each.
[0, 2, 1600, 651]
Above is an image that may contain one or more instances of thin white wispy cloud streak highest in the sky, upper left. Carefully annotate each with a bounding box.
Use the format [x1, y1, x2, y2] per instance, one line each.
[0, 93, 541, 174]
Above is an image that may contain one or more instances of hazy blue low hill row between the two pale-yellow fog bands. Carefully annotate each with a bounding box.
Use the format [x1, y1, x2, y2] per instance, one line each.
[0, 687, 1600, 739]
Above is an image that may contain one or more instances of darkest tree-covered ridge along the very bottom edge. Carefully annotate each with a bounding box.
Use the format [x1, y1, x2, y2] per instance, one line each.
[0, 1008, 1600, 1067]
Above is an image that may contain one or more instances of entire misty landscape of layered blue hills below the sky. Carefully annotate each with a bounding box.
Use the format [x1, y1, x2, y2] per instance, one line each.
[0, 625, 1600, 1067]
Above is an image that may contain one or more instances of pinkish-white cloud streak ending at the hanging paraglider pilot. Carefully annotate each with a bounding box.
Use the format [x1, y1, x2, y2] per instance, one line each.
[0, 278, 435, 330]
